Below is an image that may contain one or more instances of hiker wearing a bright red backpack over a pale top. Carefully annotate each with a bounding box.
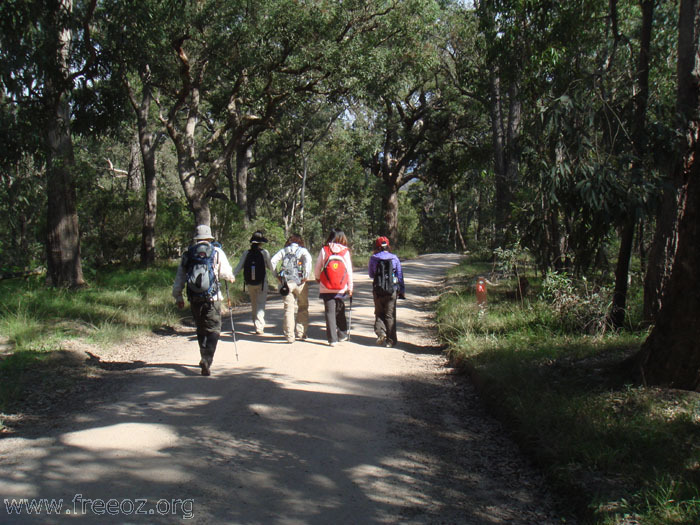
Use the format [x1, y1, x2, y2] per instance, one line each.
[314, 228, 353, 346]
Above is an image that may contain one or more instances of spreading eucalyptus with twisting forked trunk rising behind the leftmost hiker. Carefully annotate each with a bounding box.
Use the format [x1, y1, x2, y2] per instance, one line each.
[133, 0, 410, 229]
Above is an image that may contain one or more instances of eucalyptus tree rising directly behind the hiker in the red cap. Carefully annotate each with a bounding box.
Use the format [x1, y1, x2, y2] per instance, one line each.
[358, 1, 443, 244]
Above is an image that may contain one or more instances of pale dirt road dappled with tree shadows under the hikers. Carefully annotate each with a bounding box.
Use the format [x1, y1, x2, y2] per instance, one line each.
[0, 255, 559, 525]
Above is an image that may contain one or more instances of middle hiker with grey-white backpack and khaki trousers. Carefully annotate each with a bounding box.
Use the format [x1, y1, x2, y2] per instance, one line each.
[271, 234, 311, 343]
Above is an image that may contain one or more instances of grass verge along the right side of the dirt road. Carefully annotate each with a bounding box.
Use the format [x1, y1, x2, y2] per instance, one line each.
[437, 256, 700, 525]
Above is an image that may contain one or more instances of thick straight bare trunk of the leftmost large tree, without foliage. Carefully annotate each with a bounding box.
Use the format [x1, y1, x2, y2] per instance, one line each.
[45, 0, 85, 287]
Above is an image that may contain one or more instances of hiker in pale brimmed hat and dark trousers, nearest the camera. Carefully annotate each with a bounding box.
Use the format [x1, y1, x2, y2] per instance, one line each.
[173, 224, 236, 376]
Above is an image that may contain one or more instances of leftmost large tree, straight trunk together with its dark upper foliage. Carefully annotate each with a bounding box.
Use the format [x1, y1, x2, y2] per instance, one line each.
[0, 0, 97, 287]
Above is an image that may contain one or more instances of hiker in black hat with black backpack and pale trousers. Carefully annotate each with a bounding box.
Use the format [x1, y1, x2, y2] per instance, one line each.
[233, 231, 275, 335]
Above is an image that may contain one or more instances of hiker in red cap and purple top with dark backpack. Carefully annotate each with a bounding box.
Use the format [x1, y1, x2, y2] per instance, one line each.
[369, 237, 406, 346]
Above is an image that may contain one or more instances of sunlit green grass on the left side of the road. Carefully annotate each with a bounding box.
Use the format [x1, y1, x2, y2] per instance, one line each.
[0, 263, 249, 430]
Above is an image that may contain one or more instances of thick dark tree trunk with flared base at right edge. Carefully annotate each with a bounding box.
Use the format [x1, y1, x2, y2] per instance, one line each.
[638, 0, 700, 391]
